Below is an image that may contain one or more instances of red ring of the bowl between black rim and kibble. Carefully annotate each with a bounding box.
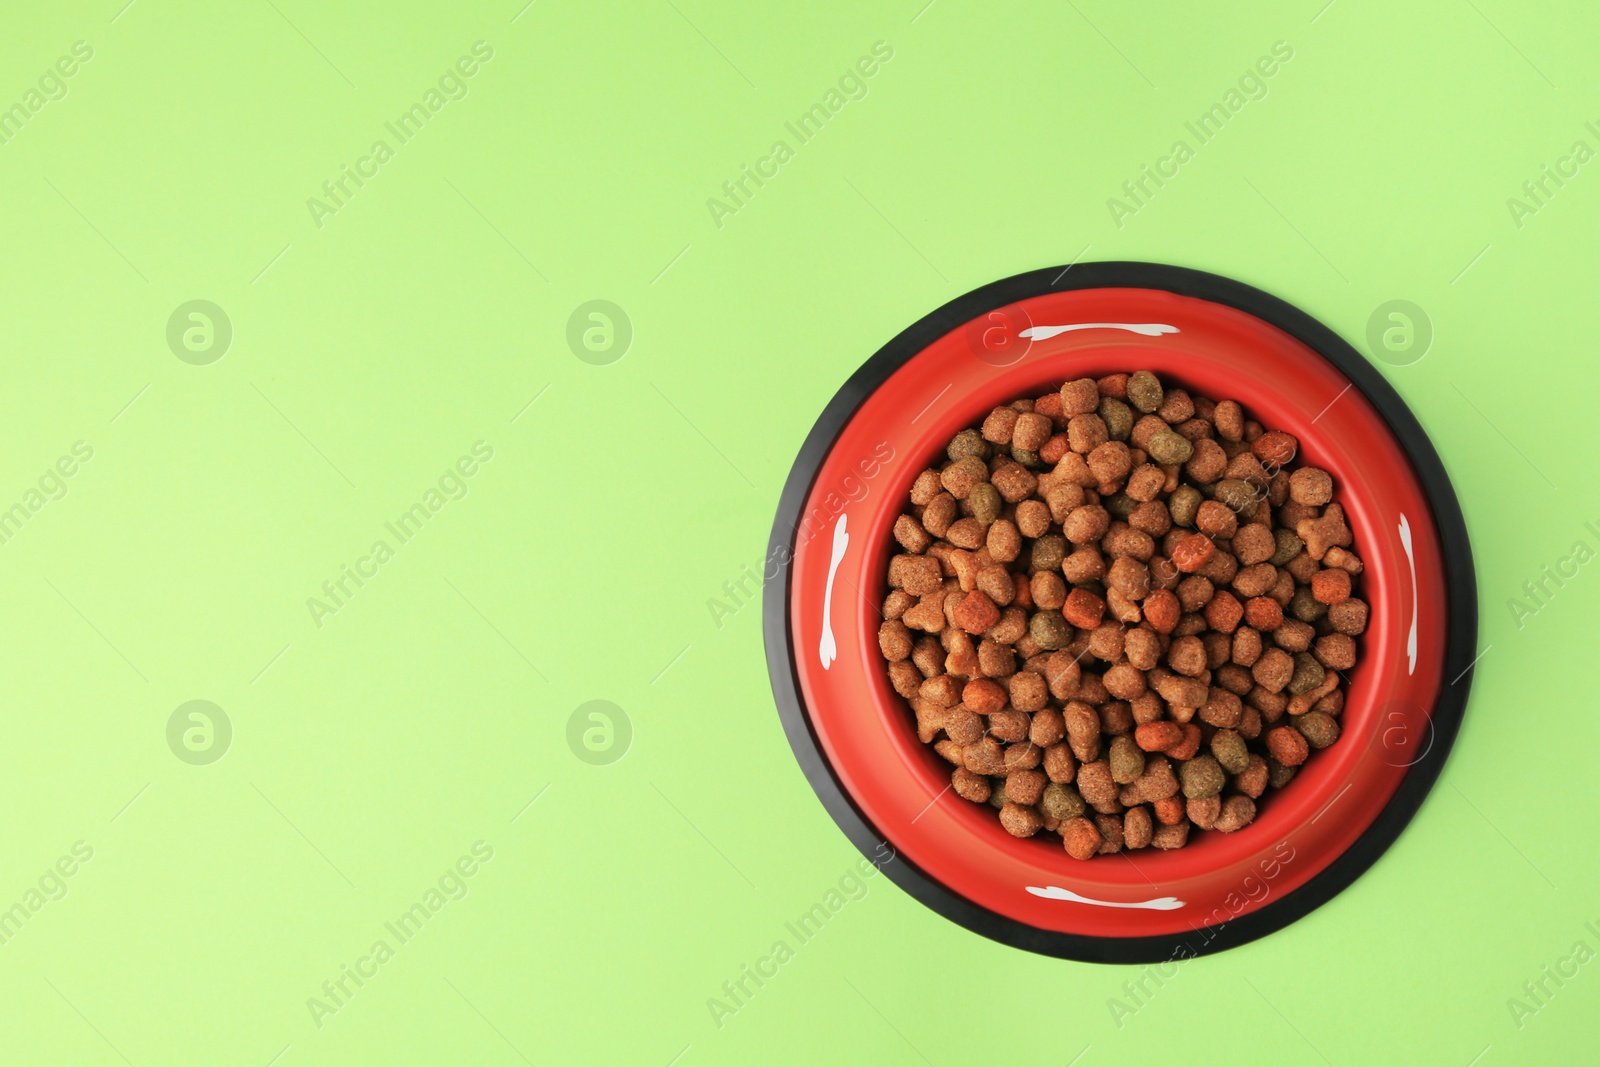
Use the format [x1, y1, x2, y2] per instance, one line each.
[789, 288, 1445, 937]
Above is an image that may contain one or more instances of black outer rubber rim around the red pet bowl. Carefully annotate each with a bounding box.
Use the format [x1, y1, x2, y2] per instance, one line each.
[762, 261, 1478, 963]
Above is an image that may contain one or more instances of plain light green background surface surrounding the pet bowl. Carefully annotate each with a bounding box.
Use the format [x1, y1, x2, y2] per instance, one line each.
[0, 0, 1600, 1067]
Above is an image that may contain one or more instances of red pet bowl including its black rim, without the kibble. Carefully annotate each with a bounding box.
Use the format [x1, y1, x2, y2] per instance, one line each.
[763, 262, 1477, 963]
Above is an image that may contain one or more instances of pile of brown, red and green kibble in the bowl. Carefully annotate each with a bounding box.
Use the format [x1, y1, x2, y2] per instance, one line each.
[878, 371, 1366, 859]
